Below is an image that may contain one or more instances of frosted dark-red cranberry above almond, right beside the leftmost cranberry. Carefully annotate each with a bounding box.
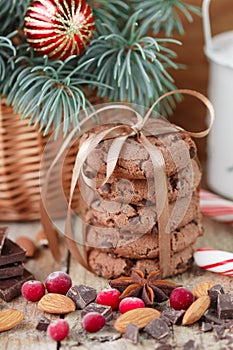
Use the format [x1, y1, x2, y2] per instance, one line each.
[45, 271, 72, 295]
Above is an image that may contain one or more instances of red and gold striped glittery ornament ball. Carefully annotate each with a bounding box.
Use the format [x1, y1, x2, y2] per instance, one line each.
[24, 0, 95, 60]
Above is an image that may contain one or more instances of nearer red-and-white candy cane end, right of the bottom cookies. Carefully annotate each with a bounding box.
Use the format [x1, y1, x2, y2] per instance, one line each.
[194, 248, 233, 276]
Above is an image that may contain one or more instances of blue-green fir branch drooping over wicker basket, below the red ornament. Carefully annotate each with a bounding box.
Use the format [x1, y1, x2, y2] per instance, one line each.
[3, 48, 109, 135]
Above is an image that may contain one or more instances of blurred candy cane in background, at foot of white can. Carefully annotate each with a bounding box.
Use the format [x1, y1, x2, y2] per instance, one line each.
[200, 190, 233, 225]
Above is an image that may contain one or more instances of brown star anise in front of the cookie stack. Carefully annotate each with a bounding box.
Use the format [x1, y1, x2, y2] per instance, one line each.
[109, 269, 180, 306]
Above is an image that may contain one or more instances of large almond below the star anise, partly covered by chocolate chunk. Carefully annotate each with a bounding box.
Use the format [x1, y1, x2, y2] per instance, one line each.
[114, 307, 160, 333]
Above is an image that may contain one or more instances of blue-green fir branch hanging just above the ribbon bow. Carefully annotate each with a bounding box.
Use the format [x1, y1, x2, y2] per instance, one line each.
[81, 12, 179, 112]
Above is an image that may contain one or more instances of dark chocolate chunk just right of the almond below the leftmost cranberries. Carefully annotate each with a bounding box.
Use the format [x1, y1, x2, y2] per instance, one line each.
[66, 284, 97, 310]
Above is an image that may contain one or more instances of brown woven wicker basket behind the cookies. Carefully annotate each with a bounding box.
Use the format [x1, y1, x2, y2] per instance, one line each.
[0, 100, 77, 221]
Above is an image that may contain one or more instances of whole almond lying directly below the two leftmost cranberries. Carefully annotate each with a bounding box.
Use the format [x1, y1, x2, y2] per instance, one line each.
[38, 293, 76, 314]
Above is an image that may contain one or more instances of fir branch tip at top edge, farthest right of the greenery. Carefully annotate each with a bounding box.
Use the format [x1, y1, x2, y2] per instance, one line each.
[130, 0, 201, 37]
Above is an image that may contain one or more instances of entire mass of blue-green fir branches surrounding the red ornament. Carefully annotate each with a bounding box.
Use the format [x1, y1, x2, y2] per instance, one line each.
[0, 0, 200, 134]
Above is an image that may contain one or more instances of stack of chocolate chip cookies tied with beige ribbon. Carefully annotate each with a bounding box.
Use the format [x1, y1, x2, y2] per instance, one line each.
[81, 126, 202, 278]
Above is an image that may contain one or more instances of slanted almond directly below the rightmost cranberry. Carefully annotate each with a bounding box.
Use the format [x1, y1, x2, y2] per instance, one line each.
[182, 295, 210, 326]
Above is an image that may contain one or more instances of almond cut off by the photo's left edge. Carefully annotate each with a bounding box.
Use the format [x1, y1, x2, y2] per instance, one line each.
[0, 309, 24, 332]
